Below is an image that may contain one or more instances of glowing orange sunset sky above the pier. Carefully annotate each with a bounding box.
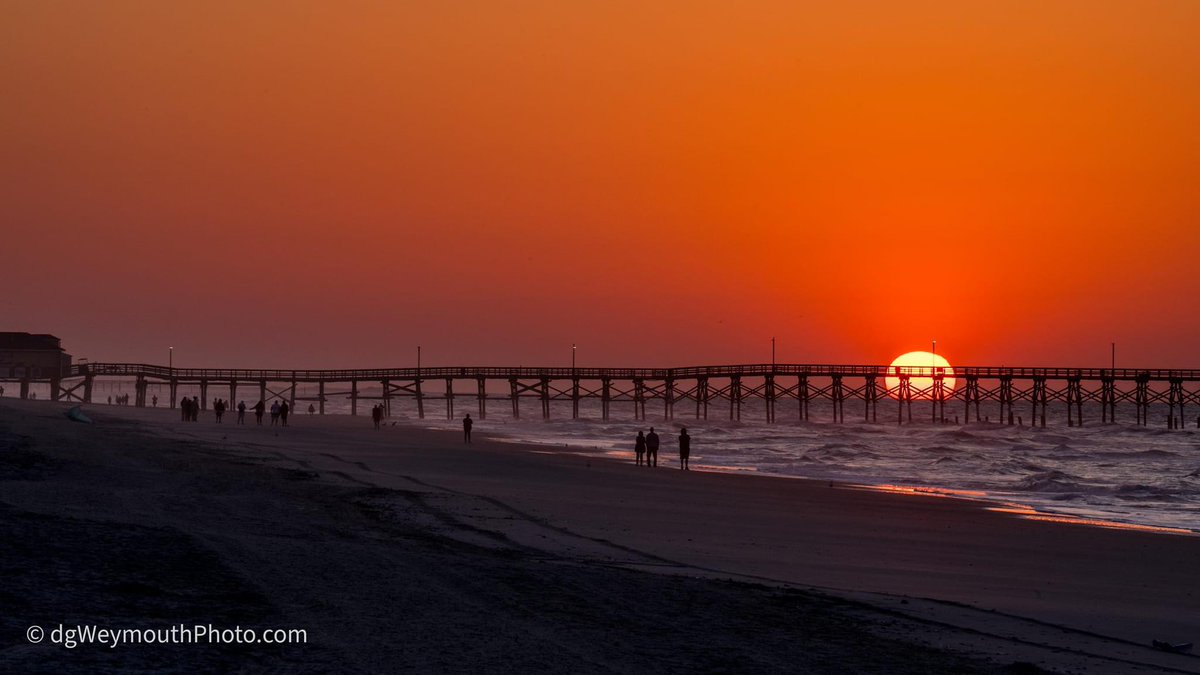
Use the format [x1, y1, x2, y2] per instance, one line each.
[0, 0, 1200, 368]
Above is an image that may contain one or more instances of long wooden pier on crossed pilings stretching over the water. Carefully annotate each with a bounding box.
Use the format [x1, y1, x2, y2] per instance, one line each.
[9, 363, 1200, 429]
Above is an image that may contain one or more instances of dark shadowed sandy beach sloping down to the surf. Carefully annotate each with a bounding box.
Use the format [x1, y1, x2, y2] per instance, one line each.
[0, 400, 1200, 673]
